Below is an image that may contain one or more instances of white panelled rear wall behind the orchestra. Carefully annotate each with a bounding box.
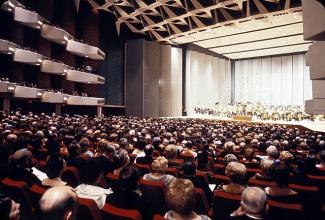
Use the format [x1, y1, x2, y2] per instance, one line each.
[234, 54, 312, 106]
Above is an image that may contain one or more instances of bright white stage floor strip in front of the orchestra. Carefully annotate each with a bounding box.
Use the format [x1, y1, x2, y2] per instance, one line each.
[170, 114, 325, 133]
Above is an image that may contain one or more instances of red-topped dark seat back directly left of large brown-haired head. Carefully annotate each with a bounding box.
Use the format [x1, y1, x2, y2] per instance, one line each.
[140, 179, 167, 216]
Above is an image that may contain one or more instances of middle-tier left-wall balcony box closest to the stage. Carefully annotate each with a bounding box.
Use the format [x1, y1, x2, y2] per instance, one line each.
[67, 69, 105, 84]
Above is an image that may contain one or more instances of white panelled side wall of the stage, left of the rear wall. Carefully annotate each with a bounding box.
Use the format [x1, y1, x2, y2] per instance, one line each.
[186, 50, 231, 116]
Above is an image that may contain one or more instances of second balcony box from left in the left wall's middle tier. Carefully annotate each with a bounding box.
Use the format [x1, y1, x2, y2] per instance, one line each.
[14, 48, 44, 66]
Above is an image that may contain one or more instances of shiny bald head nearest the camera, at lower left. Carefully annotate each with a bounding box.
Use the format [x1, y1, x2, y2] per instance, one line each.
[39, 186, 77, 220]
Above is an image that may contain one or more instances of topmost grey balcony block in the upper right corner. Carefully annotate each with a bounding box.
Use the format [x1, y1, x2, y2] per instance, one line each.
[302, 0, 325, 40]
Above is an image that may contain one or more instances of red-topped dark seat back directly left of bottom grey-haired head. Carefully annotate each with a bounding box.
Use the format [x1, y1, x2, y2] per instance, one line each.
[212, 191, 241, 219]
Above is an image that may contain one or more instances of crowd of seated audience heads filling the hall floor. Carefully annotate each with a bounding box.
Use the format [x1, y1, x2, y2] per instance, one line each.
[0, 112, 325, 219]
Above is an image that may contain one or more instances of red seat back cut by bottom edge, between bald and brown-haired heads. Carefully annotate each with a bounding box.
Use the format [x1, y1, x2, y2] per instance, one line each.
[101, 204, 142, 220]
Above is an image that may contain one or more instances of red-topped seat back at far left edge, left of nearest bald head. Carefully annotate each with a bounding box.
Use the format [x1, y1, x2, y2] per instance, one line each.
[0, 178, 34, 219]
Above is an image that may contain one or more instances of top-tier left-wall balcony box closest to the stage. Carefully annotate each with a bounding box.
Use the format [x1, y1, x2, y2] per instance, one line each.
[67, 40, 105, 60]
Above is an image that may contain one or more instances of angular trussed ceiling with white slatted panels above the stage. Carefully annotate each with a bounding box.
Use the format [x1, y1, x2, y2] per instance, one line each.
[79, 0, 310, 59]
